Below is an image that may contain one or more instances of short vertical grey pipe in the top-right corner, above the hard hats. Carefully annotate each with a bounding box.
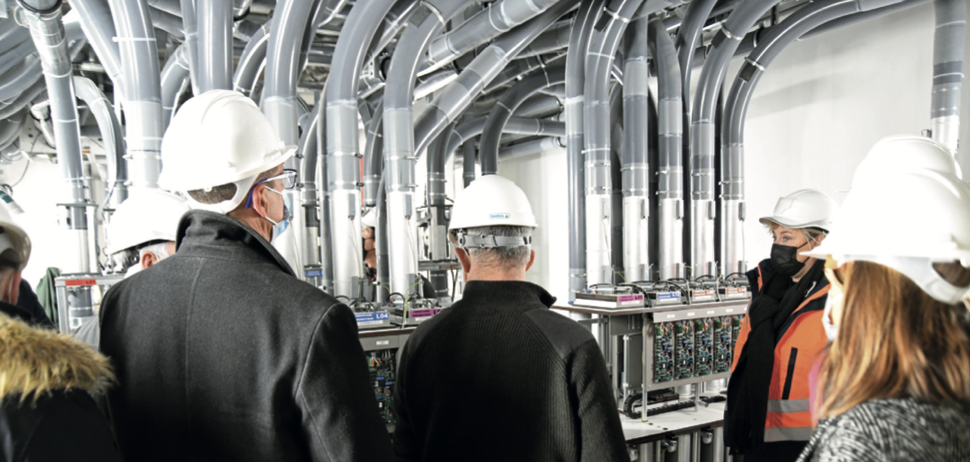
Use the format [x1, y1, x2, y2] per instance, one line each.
[930, 0, 967, 155]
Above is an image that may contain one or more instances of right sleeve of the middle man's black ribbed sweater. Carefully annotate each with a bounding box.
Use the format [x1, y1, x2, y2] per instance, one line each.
[568, 340, 630, 461]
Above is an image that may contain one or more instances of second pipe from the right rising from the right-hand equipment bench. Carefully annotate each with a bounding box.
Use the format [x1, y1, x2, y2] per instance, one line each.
[689, 0, 779, 277]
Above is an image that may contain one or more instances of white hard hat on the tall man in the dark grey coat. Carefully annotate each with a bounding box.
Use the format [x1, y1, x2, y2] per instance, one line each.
[158, 90, 296, 213]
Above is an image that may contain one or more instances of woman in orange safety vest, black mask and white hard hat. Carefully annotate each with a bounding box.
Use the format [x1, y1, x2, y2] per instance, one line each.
[724, 189, 838, 462]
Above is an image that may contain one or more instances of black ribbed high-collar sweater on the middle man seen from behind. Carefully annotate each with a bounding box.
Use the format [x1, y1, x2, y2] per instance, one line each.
[394, 281, 629, 462]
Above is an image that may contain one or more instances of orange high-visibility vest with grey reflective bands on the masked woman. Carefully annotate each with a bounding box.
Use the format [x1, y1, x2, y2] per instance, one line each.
[731, 265, 829, 443]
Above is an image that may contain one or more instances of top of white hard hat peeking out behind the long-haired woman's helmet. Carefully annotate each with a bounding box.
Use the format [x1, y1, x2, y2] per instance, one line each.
[852, 135, 963, 188]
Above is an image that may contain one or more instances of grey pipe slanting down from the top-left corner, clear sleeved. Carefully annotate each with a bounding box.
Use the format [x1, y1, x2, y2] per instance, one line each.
[20, 0, 90, 272]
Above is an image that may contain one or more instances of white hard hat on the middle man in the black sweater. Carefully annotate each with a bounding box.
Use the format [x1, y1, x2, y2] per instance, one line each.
[448, 175, 536, 231]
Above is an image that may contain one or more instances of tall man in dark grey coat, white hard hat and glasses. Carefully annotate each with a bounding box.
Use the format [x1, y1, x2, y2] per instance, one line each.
[100, 90, 392, 462]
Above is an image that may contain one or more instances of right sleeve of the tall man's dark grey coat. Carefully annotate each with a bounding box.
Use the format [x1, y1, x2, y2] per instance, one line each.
[297, 305, 393, 462]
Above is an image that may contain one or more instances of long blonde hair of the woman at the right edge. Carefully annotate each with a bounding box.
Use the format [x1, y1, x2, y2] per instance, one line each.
[818, 261, 970, 418]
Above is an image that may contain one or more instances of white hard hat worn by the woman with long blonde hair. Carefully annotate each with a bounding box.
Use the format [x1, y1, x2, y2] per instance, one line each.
[803, 170, 970, 304]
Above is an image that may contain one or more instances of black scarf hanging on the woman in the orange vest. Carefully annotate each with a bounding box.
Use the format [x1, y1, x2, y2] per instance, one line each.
[724, 260, 825, 454]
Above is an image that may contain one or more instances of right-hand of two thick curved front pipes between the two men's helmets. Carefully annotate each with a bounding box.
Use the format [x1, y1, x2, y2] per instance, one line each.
[383, 0, 480, 297]
